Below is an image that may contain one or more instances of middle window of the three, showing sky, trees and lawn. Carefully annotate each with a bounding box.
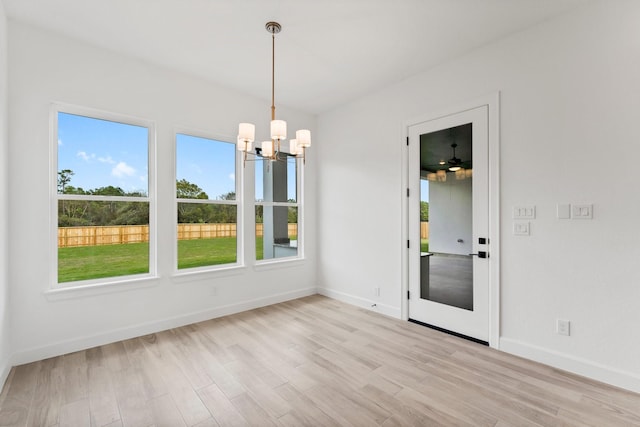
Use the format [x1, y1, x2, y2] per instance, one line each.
[176, 133, 238, 270]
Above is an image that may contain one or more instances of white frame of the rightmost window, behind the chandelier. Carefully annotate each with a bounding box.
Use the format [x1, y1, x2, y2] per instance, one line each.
[252, 157, 305, 269]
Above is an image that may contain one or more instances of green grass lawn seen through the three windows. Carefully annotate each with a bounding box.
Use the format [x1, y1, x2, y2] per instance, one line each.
[58, 237, 263, 283]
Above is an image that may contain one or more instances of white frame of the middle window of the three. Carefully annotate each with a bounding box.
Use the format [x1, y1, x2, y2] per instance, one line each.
[172, 127, 245, 278]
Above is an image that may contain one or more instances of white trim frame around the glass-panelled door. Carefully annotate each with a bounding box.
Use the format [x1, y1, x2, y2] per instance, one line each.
[400, 92, 500, 348]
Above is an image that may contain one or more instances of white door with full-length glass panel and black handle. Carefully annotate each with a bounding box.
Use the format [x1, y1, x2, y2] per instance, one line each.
[407, 105, 492, 343]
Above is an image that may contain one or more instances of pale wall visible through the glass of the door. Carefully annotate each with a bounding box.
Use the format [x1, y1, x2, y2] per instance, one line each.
[429, 179, 473, 255]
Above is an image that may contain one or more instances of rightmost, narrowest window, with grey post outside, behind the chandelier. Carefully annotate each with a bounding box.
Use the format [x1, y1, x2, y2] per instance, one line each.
[255, 157, 301, 260]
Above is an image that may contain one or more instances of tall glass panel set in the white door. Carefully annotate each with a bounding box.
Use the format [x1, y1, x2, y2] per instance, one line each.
[420, 123, 473, 310]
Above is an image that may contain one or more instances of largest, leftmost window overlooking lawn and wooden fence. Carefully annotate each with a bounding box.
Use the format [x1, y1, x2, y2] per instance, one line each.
[52, 106, 155, 286]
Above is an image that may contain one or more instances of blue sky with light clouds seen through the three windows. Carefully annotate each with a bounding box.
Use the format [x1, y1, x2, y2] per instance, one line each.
[58, 113, 296, 200]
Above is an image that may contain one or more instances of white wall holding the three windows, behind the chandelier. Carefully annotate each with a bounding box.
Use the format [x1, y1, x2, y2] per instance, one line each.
[9, 22, 316, 363]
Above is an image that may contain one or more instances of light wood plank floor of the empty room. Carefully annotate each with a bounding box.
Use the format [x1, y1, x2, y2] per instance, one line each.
[0, 296, 640, 427]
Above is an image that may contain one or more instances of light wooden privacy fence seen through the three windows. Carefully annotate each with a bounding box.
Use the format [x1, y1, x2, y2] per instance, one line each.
[58, 224, 298, 248]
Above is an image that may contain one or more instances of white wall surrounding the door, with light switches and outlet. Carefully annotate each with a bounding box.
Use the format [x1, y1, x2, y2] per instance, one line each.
[318, 0, 640, 391]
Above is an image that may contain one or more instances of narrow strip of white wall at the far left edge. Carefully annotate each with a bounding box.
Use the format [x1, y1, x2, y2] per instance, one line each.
[0, 1, 11, 389]
